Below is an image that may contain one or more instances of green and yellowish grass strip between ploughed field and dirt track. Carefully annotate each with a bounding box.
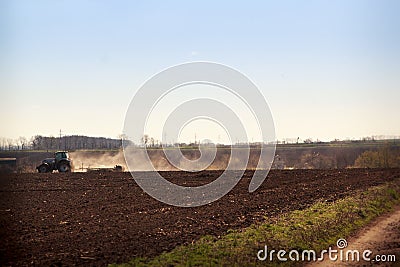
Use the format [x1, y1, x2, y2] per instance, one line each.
[110, 181, 400, 267]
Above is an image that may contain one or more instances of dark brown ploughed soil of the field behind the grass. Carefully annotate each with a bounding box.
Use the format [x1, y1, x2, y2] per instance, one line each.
[0, 169, 400, 266]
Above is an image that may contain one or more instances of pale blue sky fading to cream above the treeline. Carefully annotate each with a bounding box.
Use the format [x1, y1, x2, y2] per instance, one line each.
[0, 0, 400, 142]
